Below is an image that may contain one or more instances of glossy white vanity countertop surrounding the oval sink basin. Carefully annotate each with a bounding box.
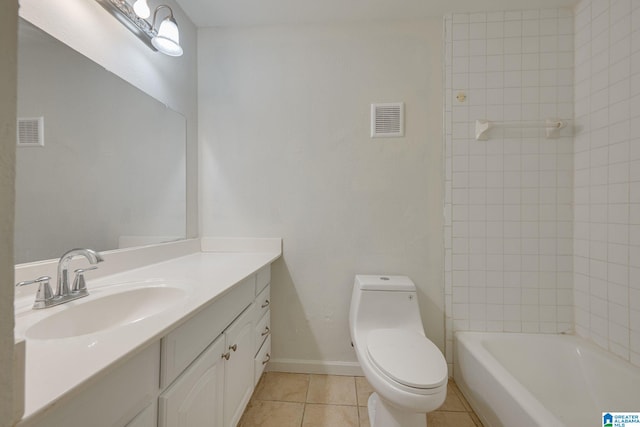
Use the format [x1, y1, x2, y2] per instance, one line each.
[15, 244, 281, 419]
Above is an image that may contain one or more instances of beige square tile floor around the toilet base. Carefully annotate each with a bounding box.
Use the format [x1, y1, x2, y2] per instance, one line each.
[239, 372, 482, 427]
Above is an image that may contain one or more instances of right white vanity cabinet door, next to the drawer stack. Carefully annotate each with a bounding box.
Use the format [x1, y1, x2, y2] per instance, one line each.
[224, 307, 255, 427]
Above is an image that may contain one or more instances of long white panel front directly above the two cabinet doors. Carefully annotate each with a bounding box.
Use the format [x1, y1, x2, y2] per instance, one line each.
[160, 276, 255, 388]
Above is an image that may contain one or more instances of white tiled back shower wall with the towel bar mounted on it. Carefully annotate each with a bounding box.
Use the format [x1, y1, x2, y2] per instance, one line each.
[445, 8, 576, 363]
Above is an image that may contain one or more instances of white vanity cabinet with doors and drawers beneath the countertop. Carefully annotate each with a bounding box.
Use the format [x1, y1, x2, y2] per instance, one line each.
[18, 256, 271, 427]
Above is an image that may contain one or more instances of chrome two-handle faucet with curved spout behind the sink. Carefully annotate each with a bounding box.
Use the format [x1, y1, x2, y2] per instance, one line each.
[16, 248, 104, 309]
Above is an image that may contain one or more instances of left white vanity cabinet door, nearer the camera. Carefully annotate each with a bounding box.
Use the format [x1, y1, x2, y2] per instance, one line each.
[158, 336, 225, 427]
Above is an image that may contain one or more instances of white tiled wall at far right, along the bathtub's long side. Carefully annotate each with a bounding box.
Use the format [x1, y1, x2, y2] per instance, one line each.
[574, 0, 640, 366]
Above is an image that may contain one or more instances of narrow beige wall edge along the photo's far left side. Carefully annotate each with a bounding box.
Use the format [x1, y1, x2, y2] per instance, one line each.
[0, 0, 18, 427]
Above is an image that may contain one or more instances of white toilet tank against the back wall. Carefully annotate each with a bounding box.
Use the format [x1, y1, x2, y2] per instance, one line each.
[349, 275, 424, 335]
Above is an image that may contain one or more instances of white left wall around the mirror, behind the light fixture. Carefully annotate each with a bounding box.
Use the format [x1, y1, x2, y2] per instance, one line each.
[20, 0, 198, 236]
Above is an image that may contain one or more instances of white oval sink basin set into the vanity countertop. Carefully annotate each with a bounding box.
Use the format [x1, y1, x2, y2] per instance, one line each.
[25, 286, 187, 340]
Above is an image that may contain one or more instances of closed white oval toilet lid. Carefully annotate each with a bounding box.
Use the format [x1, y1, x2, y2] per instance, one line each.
[367, 329, 447, 389]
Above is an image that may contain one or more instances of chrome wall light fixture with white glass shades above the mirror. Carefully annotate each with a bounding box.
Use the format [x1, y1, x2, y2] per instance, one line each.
[96, 0, 183, 56]
